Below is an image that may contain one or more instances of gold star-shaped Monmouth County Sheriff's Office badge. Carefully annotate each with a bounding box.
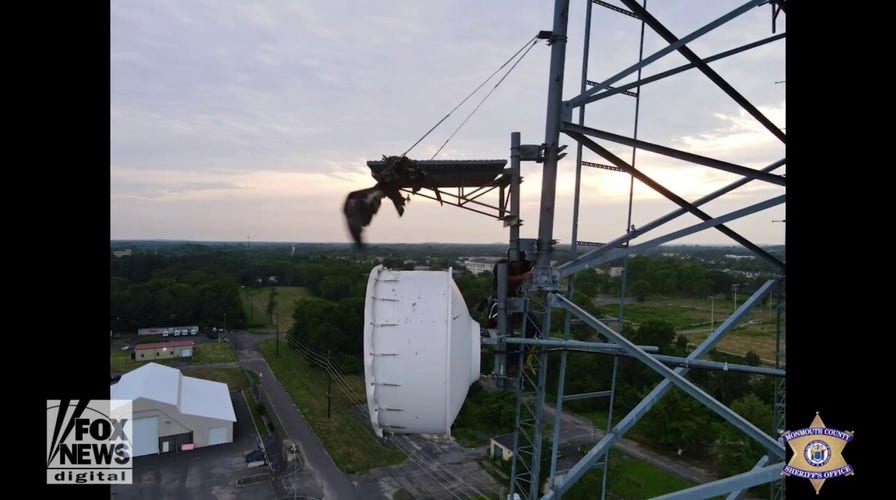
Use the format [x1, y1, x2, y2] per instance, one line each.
[781, 412, 853, 495]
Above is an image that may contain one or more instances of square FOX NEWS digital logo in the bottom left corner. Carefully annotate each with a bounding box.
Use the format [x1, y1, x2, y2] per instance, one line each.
[47, 399, 133, 484]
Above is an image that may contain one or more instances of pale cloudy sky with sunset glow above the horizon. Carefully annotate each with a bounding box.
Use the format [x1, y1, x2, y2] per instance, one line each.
[109, 0, 786, 245]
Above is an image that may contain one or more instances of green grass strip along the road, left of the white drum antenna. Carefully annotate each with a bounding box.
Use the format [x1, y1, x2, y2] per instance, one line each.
[258, 339, 406, 474]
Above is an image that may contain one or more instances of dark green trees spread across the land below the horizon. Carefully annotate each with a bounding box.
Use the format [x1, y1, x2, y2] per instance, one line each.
[110, 242, 775, 480]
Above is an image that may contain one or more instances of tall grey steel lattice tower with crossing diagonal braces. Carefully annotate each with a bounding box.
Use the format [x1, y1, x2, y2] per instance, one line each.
[498, 0, 786, 499]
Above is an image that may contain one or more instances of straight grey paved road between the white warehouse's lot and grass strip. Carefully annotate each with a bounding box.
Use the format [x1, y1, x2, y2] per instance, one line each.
[231, 332, 361, 500]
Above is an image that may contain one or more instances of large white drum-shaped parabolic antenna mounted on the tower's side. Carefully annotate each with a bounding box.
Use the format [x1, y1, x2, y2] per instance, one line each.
[364, 265, 480, 437]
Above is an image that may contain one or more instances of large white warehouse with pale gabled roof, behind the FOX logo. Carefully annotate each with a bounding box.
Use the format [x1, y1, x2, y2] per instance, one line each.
[110, 363, 236, 457]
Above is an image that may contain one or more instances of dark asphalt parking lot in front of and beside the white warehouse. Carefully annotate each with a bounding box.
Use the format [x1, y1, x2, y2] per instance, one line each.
[112, 392, 276, 500]
